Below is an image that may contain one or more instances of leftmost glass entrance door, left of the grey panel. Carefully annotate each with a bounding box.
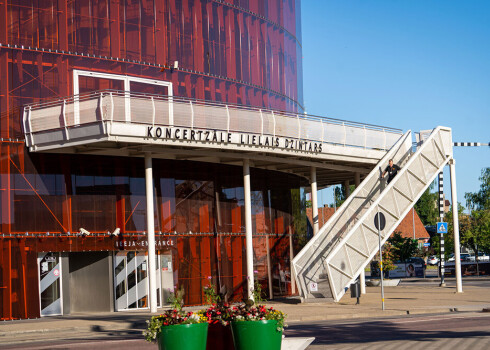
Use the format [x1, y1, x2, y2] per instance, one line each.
[37, 253, 63, 316]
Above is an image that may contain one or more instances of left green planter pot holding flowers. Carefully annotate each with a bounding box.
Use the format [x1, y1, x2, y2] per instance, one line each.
[158, 323, 208, 350]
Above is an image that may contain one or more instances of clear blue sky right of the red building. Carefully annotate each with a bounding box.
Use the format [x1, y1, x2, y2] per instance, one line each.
[301, 0, 490, 211]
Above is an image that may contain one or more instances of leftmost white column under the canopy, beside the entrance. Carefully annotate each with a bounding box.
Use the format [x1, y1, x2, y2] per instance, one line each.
[145, 153, 157, 313]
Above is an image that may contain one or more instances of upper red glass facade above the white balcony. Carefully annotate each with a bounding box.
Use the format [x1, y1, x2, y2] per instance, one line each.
[0, 0, 302, 137]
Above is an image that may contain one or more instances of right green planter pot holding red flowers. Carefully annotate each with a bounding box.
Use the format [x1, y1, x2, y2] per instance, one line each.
[231, 320, 282, 350]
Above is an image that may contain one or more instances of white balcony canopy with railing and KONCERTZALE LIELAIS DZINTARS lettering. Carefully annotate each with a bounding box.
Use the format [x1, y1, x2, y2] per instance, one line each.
[23, 90, 402, 187]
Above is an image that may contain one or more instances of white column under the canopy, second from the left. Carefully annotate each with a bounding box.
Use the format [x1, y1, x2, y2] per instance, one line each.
[243, 159, 254, 300]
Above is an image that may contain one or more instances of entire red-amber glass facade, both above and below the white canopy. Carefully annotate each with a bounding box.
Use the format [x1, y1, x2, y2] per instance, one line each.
[0, 0, 303, 320]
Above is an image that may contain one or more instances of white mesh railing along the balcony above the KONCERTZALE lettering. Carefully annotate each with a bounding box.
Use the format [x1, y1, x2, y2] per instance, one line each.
[23, 90, 402, 150]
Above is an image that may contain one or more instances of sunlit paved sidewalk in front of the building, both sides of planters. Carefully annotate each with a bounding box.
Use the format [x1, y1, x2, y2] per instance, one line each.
[0, 278, 490, 348]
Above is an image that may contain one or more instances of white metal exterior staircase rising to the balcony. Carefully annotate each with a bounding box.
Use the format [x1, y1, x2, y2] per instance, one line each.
[293, 127, 452, 301]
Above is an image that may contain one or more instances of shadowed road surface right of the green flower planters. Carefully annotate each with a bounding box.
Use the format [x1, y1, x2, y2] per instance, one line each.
[286, 313, 490, 350]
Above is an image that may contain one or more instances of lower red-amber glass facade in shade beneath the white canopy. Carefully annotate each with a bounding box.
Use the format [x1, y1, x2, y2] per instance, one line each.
[0, 143, 300, 314]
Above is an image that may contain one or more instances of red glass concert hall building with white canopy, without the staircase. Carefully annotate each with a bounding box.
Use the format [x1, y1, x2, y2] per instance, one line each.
[0, 0, 401, 320]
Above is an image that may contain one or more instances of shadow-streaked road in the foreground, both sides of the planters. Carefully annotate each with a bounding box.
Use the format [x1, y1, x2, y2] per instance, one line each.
[0, 313, 490, 350]
